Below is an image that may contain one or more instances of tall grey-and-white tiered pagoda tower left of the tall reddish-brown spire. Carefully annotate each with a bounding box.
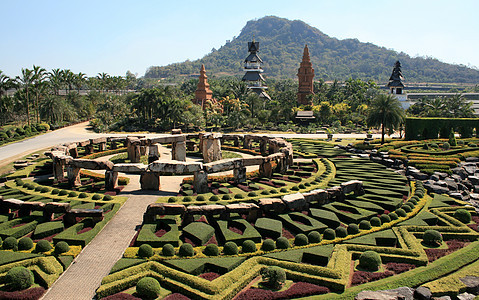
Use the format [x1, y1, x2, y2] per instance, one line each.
[242, 38, 271, 100]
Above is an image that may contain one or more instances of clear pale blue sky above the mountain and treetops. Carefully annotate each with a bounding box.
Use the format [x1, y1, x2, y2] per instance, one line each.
[0, 0, 479, 76]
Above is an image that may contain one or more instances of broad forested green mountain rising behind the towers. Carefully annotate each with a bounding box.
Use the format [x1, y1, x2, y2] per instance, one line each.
[145, 16, 479, 83]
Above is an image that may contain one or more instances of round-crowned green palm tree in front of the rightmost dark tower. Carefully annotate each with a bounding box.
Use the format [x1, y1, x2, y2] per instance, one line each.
[366, 94, 405, 144]
